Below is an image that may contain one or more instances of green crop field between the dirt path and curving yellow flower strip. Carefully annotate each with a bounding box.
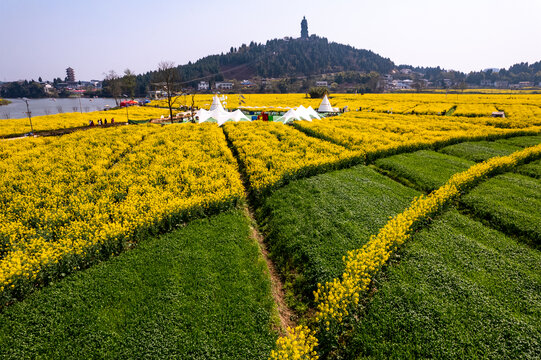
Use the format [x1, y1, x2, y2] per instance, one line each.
[263, 166, 419, 310]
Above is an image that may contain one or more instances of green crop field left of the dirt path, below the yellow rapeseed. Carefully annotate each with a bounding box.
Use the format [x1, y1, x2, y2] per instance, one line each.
[0, 211, 277, 359]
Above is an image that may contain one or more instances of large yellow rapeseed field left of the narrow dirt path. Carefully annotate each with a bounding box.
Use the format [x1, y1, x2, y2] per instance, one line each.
[0, 124, 244, 299]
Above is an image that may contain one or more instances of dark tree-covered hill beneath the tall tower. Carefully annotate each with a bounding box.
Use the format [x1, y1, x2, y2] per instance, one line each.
[138, 35, 395, 91]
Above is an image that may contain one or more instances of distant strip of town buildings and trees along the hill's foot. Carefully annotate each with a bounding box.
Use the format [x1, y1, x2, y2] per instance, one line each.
[0, 67, 541, 99]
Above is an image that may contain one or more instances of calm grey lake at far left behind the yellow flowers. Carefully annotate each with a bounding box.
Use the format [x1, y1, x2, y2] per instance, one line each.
[0, 98, 116, 119]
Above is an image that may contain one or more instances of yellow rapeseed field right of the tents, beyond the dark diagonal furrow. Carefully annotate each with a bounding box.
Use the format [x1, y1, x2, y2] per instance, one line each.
[295, 112, 541, 158]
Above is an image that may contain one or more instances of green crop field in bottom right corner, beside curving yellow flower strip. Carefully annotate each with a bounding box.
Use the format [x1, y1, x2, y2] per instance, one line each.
[344, 210, 541, 359]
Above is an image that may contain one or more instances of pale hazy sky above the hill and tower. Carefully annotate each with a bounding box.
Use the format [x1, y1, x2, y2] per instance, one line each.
[0, 0, 541, 81]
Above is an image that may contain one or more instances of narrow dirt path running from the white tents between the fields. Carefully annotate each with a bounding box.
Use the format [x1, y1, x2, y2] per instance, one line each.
[222, 129, 295, 335]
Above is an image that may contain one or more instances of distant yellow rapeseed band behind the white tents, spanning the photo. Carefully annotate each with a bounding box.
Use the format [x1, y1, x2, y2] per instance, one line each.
[5, 93, 541, 137]
